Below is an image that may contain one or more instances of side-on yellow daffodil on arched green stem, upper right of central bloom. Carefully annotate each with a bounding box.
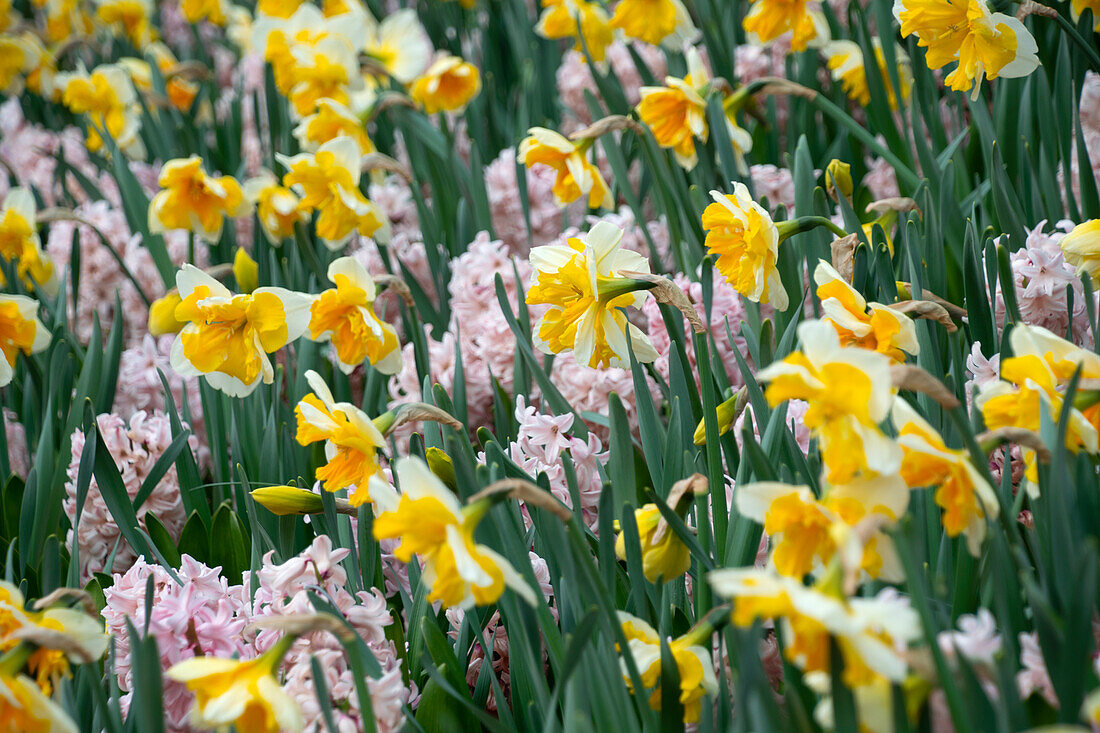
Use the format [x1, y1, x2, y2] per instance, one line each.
[703, 183, 788, 310]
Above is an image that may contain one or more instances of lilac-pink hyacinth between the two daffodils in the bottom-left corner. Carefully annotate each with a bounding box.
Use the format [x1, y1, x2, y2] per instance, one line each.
[103, 555, 254, 733]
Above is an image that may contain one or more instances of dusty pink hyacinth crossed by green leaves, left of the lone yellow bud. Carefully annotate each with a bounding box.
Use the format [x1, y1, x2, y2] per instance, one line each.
[64, 411, 197, 580]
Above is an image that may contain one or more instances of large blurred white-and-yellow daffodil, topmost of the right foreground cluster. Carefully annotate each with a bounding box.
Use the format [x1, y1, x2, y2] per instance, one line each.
[757, 320, 901, 485]
